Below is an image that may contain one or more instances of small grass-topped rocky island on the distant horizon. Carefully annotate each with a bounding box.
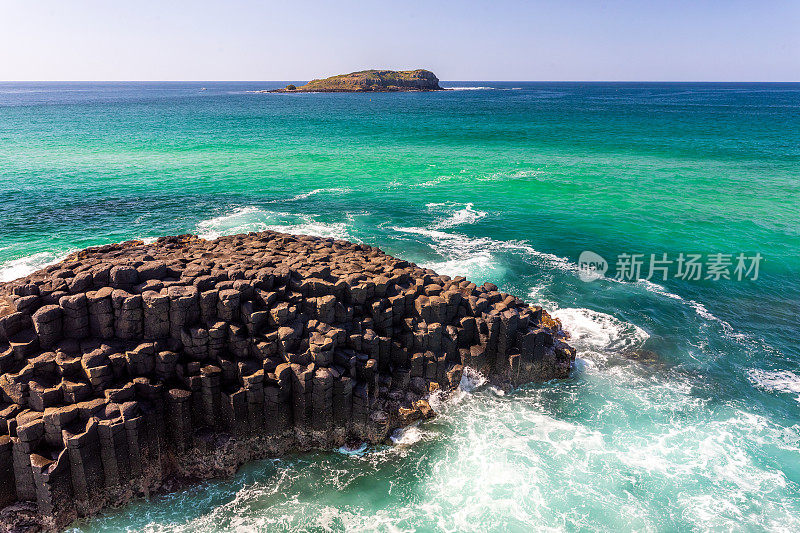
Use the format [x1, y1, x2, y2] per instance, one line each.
[268, 69, 444, 93]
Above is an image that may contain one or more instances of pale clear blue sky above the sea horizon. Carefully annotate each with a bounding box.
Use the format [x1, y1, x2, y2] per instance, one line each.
[0, 0, 800, 81]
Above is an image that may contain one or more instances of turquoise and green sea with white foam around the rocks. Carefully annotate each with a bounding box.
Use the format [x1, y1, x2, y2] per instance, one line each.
[0, 82, 800, 531]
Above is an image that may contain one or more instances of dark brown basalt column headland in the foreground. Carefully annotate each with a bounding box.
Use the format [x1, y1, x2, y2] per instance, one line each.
[0, 232, 575, 529]
